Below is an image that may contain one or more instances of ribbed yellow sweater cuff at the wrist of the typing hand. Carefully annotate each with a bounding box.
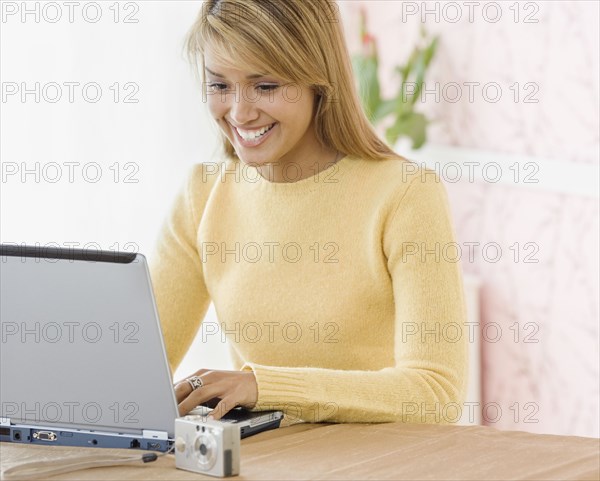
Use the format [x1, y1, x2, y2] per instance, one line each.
[241, 362, 314, 411]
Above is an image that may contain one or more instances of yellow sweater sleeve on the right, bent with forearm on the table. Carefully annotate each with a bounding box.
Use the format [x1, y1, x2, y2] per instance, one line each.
[242, 171, 467, 423]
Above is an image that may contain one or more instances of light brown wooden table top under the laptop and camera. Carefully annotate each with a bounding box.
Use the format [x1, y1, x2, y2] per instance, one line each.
[0, 423, 600, 480]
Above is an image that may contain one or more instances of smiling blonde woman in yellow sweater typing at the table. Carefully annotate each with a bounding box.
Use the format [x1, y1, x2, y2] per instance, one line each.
[152, 0, 467, 423]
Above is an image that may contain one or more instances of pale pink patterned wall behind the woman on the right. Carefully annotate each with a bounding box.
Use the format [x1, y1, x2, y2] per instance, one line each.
[340, 1, 600, 436]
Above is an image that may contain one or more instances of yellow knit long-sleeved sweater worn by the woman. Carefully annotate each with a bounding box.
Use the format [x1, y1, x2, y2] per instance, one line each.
[150, 156, 467, 422]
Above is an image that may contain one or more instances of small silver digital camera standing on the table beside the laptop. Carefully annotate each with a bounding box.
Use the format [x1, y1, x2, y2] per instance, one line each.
[175, 415, 240, 477]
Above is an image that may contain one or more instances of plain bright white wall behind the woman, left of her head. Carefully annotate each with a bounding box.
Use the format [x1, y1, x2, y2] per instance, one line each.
[0, 1, 228, 380]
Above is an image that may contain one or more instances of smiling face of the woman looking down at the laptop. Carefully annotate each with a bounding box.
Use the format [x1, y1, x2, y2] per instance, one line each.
[204, 49, 331, 182]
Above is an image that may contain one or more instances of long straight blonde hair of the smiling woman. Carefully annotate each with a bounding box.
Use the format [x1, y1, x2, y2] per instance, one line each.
[186, 0, 402, 160]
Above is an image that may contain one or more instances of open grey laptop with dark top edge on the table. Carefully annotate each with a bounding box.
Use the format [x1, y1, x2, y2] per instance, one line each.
[0, 245, 283, 451]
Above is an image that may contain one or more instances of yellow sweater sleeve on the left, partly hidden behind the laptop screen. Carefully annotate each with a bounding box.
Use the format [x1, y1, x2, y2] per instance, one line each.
[150, 164, 210, 373]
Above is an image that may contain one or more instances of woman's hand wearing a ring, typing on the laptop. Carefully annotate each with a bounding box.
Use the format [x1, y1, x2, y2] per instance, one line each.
[175, 369, 258, 420]
